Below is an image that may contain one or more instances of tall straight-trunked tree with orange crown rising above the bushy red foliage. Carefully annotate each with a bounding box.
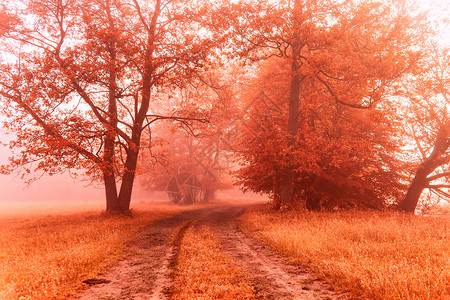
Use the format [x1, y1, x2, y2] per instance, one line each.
[235, 1, 427, 209]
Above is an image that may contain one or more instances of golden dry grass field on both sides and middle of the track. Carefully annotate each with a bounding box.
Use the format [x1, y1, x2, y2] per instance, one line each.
[0, 199, 450, 300]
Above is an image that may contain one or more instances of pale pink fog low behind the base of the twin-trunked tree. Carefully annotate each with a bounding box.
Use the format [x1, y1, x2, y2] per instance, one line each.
[0, 169, 179, 217]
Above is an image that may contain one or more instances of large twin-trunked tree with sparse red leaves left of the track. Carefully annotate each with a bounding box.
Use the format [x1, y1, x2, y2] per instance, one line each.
[0, 0, 222, 212]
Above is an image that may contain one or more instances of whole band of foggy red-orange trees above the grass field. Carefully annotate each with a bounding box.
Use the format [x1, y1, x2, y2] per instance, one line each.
[0, 0, 450, 213]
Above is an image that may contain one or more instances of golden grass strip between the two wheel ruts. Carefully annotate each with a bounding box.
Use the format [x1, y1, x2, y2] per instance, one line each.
[172, 226, 255, 299]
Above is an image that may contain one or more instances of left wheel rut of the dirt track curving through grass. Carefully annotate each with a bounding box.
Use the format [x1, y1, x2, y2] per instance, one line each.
[79, 209, 209, 300]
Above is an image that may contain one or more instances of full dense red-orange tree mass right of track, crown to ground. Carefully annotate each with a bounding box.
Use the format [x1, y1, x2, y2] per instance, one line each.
[229, 1, 428, 209]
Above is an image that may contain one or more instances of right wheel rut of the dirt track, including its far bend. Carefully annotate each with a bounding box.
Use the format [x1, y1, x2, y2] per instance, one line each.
[198, 207, 347, 299]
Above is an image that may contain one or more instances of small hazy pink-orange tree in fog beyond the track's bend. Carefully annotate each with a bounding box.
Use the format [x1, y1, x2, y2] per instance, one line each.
[139, 123, 230, 202]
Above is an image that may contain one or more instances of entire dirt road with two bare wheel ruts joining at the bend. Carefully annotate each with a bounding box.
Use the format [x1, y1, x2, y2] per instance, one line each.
[80, 204, 344, 300]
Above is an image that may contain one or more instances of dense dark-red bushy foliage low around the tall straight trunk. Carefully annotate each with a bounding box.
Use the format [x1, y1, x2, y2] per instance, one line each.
[236, 59, 405, 210]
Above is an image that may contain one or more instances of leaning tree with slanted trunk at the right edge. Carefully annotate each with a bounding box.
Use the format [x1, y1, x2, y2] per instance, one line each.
[399, 45, 450, 213]
